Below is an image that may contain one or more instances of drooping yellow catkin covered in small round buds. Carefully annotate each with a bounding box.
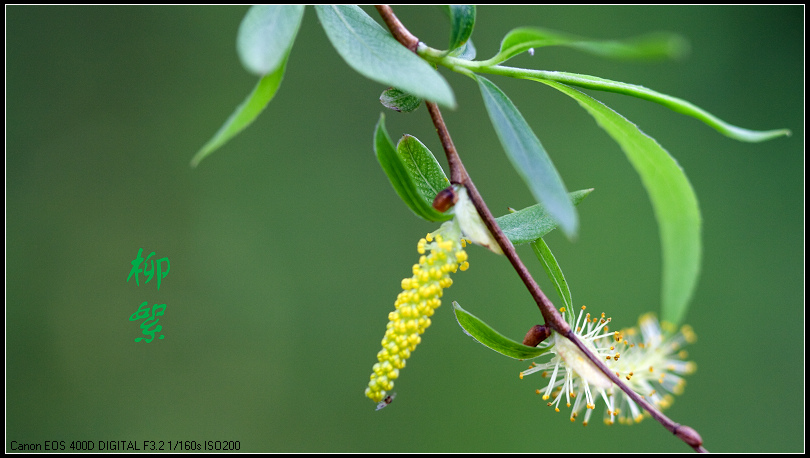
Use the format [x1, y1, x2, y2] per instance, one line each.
[366, 218, 469, 402]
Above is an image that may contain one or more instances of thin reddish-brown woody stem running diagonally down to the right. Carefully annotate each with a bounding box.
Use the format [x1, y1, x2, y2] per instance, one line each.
[376, 5, 706, 452]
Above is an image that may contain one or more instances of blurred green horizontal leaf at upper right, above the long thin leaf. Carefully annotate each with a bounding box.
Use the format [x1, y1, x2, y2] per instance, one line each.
[486, 27, 689, 65]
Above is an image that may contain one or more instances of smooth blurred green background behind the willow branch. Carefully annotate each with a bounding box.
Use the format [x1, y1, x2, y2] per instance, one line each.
[6, 6, 805, 452]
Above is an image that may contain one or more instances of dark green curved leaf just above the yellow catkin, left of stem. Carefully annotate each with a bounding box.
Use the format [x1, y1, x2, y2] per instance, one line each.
[374, 114, 452, 221]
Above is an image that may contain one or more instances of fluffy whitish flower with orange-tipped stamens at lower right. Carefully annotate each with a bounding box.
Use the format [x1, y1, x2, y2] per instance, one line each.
[522, 306, 696, 425]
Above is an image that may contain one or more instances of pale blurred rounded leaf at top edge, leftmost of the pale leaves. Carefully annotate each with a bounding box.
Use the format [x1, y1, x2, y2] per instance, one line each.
[236, 5, 304, 76]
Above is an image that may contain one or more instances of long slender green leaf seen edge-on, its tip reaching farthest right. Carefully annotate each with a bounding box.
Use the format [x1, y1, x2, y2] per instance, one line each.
[518, 70, 790, 142]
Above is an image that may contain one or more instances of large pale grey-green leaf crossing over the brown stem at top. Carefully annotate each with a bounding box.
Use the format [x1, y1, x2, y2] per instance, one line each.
[315, 5, 456, 108]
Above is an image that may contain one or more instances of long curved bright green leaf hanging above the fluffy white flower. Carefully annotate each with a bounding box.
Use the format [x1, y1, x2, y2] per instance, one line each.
[543, 81, 701, 324]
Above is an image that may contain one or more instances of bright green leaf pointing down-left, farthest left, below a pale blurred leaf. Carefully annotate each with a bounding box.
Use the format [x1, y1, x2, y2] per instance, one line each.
[191, 59, 287, 167]
